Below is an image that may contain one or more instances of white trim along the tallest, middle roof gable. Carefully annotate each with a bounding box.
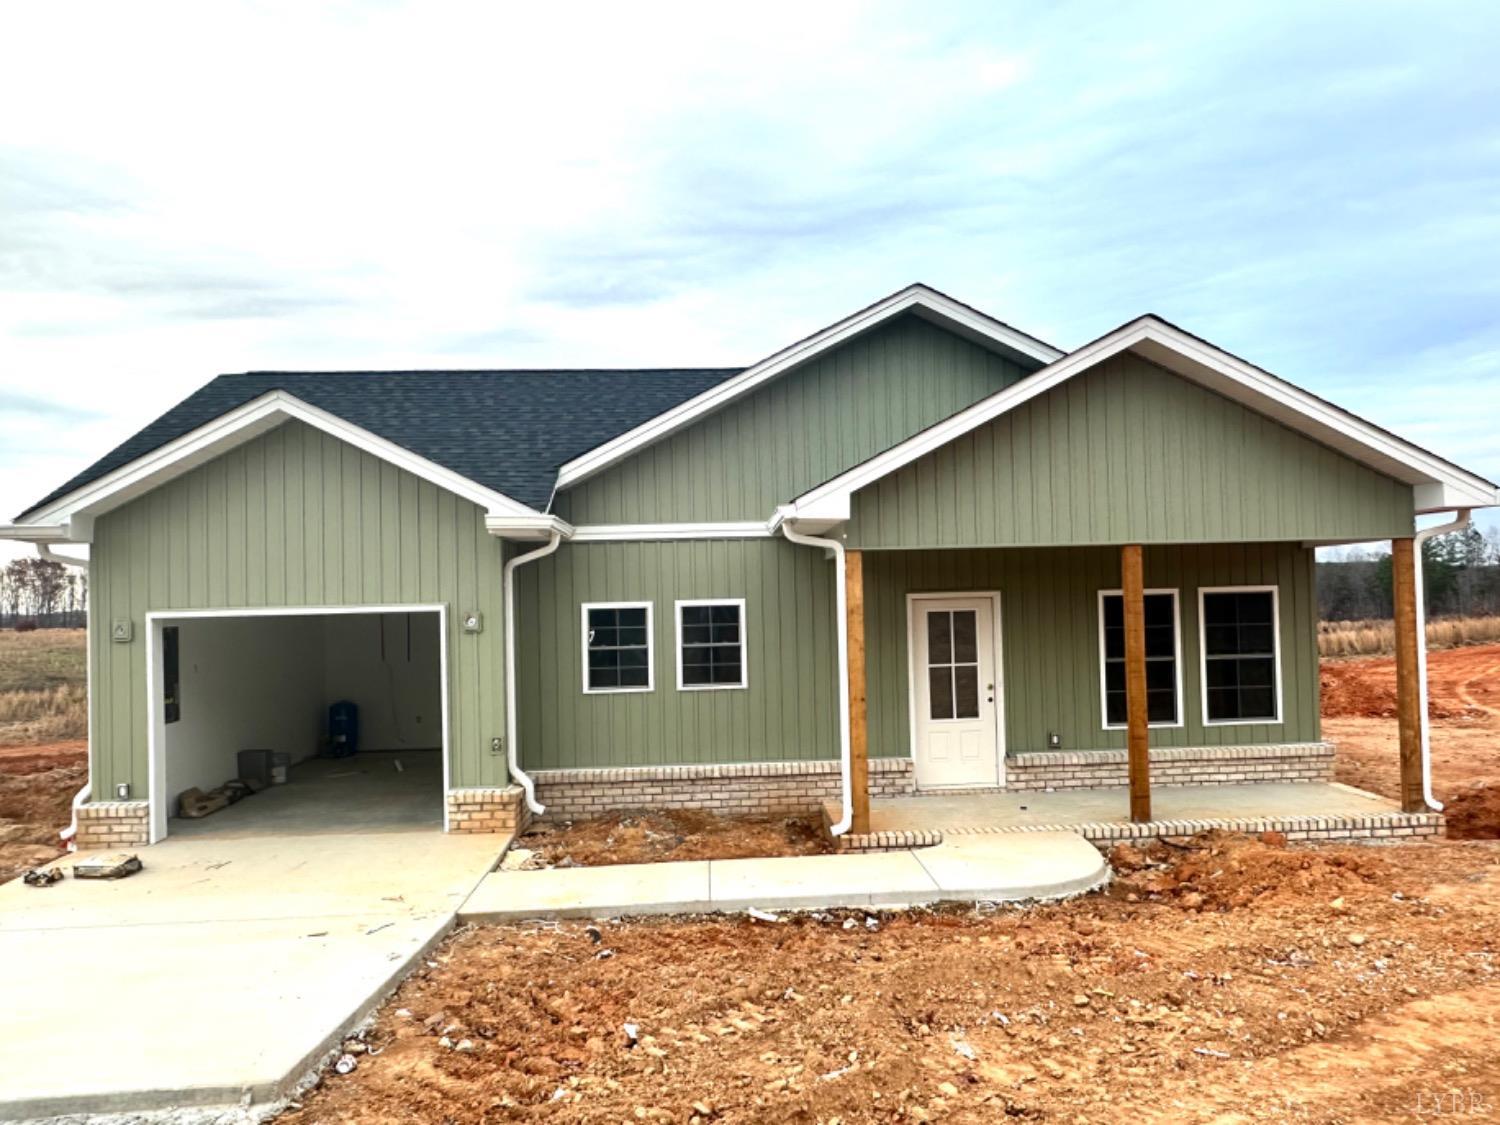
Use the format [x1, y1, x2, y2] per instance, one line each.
[557, 285, 1064, 489]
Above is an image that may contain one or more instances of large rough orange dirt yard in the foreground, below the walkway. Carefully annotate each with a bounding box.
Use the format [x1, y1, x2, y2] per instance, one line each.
[282, 837, 1500, 1125]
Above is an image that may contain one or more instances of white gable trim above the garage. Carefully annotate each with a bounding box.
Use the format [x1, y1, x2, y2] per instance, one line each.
[27, 390, 542, 524]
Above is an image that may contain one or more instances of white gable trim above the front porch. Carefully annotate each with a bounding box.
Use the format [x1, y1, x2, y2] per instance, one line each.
[788, 317, 1500, 522]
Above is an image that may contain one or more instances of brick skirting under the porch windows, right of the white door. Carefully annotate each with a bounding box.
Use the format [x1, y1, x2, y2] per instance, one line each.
[1005, 743, 1334, 791]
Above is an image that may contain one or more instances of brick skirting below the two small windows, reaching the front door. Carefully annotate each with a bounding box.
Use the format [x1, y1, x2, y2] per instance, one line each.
[531, 758, 912, 821]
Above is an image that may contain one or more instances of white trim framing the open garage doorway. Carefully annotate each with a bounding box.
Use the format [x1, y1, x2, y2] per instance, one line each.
[146, 603, 453, 843]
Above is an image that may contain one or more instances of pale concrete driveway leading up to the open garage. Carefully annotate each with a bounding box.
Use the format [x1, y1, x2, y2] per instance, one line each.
[0, 831, 506, 1119]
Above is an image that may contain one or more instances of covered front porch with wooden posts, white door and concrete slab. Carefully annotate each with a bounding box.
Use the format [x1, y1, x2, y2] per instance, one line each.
[830, 539, 1443, 848]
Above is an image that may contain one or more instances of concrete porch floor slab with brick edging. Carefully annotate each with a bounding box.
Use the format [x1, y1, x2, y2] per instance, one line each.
[824, 782, 1443, 851]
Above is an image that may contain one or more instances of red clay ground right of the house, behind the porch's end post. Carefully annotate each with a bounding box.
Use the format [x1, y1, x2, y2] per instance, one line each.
[1323, 645, 1500, 839]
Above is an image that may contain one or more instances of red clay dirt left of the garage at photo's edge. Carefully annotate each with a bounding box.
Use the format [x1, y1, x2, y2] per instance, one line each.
[0, 743, 89, 884]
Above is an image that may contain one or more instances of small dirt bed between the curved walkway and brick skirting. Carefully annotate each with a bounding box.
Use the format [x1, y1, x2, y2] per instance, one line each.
[513, 809, 830, 867]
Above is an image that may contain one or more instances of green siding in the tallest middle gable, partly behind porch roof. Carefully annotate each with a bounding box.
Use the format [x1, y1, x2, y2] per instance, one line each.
[555, 315, 1029, 525]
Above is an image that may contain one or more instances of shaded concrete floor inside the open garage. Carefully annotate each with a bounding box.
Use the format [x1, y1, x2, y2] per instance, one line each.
[167, 750, 443, 837]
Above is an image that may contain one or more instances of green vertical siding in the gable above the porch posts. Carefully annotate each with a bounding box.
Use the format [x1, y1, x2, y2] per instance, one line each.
[848, 356, 1413, 549]
